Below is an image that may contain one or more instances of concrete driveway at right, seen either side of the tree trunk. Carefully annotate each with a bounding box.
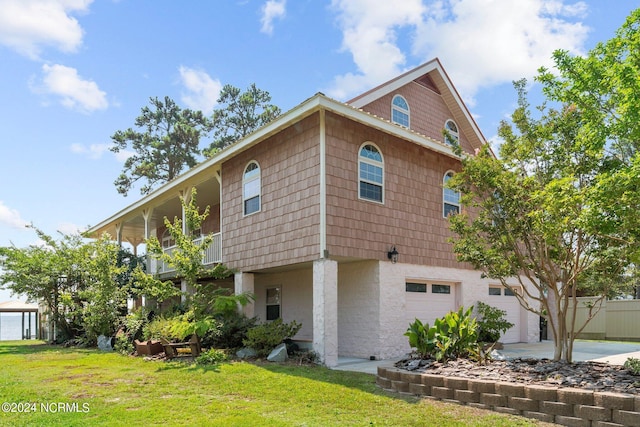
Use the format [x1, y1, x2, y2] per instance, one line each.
[498, 340, 640, 365]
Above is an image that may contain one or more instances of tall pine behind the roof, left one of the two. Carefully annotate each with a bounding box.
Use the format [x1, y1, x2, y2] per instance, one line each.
[110, 96, 209, 196]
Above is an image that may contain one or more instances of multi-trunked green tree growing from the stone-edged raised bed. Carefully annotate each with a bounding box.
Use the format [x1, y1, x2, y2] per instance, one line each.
[449, 80, 629, 362]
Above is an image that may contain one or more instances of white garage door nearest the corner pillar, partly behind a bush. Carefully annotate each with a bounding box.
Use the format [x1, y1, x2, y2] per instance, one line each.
[405, 282, 457, 326]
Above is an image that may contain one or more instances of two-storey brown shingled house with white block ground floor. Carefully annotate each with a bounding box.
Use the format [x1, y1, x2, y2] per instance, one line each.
[90, 59, 539, 366]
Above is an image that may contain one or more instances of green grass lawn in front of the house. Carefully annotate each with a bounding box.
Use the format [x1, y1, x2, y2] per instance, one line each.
[0, 341, 552, 426]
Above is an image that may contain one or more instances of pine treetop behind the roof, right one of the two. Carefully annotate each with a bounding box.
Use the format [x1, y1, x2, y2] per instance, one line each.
[203, 83, 281, 157]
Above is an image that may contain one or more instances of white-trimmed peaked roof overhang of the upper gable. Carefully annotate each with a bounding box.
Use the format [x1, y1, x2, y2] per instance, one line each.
[347, 58, 486, 153]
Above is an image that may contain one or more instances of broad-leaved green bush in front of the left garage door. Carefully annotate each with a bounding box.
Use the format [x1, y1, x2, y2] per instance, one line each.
[405, 306, 478, 362]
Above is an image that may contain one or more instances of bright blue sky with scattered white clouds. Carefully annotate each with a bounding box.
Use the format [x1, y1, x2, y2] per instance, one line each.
[0, 0, 640, 302]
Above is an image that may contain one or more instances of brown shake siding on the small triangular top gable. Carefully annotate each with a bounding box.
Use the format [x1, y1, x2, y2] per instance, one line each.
[362, 82, 474, 153]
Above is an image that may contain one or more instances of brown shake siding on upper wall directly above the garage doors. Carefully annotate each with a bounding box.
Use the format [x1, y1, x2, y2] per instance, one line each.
[327, 114, 466, 268]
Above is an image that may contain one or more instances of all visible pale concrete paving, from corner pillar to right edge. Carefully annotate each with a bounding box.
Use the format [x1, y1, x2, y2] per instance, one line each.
[332, 340, 640, 375]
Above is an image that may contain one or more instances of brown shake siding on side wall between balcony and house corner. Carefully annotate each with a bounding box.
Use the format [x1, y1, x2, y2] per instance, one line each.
[222, 113, 320, 271]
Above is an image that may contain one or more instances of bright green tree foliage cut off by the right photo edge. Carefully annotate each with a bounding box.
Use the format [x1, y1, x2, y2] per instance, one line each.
[538, 9, 640, 265]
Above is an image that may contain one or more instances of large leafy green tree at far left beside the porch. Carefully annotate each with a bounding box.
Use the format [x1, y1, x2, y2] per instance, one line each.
[0, 227, 139, 344]
